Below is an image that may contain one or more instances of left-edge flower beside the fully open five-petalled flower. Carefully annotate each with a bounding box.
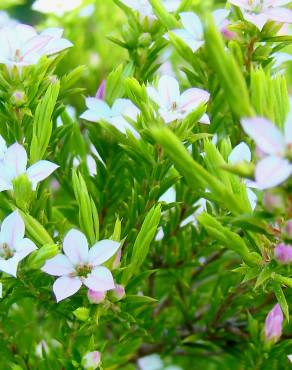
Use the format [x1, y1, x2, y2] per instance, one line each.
[0, 211, 37, 277]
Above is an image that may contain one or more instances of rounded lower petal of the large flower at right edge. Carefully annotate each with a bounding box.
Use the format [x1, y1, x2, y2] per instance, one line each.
[255, 156, 292, 189]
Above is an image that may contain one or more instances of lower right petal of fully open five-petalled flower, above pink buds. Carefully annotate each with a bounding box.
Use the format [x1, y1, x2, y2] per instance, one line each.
[83, 266, 115, 292]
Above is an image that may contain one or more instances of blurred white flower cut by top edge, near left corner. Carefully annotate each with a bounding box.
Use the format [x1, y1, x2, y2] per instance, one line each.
[32, 0, 83, 17]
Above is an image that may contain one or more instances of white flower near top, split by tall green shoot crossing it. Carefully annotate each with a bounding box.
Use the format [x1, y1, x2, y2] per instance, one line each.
[171, 9, 229, 52]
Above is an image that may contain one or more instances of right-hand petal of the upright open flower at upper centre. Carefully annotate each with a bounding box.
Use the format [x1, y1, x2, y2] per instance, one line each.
[177, 88, 210, 113]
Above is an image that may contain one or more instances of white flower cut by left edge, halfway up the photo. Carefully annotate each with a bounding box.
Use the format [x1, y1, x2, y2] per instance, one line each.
[0, 143, 59, 192]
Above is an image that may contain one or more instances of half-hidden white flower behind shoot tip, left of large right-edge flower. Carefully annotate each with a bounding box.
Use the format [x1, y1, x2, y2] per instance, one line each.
[228, 142, 258, 210]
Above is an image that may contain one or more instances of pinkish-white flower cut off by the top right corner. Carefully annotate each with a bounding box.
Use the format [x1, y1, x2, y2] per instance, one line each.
[230, 0, 292, 31]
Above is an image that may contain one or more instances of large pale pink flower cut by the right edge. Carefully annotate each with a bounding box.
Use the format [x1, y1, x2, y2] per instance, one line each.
[241, 117, 292, 189]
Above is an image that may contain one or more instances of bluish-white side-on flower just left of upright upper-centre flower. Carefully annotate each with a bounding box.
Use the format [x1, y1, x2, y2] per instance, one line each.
[81, 97, 140, 137]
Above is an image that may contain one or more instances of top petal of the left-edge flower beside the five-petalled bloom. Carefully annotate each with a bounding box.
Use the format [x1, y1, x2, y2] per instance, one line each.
[0, 211, 25, 248]
